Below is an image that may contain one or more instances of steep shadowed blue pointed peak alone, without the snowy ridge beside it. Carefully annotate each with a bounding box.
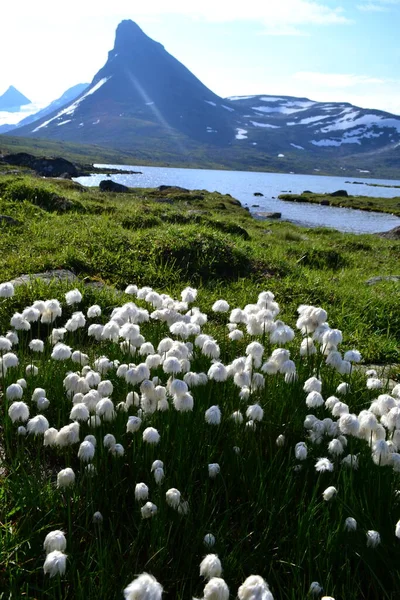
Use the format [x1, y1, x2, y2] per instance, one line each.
[16, 21, 234, 147]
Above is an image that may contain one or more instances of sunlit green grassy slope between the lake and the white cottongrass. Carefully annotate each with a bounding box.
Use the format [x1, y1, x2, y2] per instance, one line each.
[0, 171, 400, 362]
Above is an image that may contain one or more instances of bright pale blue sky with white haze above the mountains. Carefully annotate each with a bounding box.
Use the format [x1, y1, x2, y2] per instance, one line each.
[0, 0, 400, 114]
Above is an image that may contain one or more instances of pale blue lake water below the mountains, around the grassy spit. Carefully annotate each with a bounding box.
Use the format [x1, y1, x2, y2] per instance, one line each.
[77, 165, 400, 233]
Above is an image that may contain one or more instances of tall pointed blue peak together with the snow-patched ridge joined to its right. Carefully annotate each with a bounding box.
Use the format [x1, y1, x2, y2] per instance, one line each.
[13, 20, 400, 176]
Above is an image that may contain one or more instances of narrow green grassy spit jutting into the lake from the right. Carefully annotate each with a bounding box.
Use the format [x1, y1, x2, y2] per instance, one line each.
[278, 191, 400, 216]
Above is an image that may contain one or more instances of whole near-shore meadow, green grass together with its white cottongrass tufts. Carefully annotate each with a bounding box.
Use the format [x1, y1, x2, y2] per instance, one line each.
[0, 171, 400, 600]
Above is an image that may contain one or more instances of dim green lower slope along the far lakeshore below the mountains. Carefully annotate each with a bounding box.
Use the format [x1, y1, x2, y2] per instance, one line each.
[0, 135, 400, 179]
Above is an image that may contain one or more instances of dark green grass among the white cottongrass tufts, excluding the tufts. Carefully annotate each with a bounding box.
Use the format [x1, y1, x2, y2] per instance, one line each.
[0, 282, 400, 600]
